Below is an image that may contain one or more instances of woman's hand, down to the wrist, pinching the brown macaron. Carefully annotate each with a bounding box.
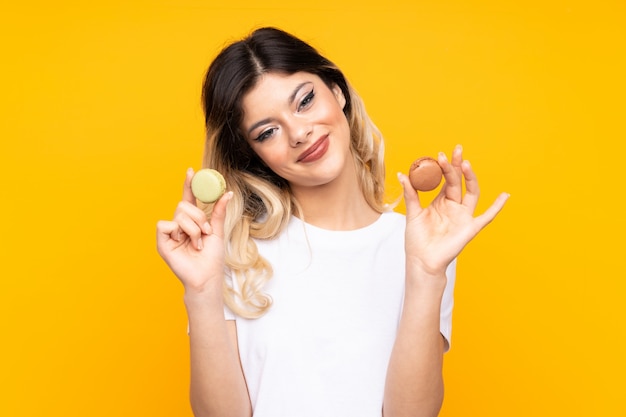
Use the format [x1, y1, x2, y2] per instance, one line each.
[398, 145, 509, 276]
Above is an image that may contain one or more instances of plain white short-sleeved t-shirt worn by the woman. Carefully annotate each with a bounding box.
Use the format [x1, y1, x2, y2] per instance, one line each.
[226, 212, 455, 417]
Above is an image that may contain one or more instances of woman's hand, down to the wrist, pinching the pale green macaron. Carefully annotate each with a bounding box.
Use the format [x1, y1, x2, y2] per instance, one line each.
[157, 168, 232, 292]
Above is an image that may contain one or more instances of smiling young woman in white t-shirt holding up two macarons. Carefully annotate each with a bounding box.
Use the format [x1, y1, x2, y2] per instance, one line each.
[157, 28, 507, 417]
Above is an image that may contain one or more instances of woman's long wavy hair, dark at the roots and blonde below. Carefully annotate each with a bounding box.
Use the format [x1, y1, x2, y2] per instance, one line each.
[202, 27, 387, 318]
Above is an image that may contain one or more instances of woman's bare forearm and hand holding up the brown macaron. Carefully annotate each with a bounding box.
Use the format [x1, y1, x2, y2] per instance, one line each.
[383, 146, 508, 417]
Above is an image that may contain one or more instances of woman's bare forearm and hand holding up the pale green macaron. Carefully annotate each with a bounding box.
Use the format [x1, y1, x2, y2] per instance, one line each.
[157, 170, 252, 417]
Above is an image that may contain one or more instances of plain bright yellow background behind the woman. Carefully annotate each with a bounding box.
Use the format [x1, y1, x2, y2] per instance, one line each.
[0, 0, 626, 417]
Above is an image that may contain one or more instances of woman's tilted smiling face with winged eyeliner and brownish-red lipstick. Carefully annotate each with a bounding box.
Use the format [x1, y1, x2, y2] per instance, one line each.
[242, 72, 351, 188]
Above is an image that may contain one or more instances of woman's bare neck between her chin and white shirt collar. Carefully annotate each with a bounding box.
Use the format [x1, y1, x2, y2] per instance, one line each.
[292, 159, 380, 230]
